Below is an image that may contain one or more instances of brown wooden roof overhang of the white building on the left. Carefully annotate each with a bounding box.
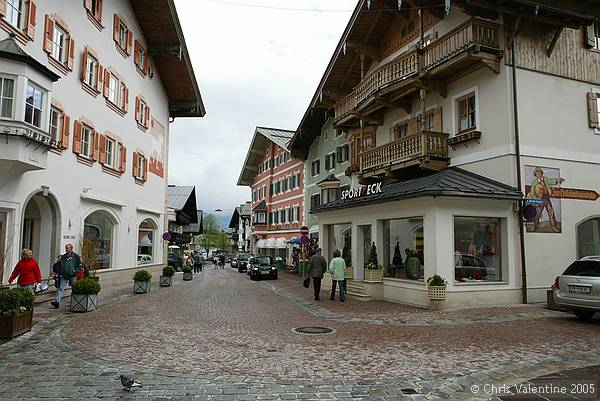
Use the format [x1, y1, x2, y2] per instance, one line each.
[131, 0, 206, 118]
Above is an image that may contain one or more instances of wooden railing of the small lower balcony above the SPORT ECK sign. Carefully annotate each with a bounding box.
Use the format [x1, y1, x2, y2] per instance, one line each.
[360, 131, 448, 172]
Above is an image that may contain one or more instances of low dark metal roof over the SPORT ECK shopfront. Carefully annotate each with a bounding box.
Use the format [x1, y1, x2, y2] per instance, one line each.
[311, 167, 523, 213]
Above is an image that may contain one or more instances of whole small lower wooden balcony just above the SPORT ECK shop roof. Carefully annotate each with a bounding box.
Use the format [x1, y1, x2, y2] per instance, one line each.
[360, 131, 448, 178]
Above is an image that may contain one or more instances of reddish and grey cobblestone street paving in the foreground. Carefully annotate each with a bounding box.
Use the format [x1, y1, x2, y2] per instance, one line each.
[0, 267, 600, 401]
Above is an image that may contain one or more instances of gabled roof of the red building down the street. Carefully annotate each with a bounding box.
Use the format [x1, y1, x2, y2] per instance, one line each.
[238, 127, 295, 186]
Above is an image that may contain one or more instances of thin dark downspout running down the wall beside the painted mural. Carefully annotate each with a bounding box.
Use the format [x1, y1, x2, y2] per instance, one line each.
[510, 42, 527, 304]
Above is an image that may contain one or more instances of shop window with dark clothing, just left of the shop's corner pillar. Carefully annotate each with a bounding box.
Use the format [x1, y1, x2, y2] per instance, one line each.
[383, 217, 425, 281]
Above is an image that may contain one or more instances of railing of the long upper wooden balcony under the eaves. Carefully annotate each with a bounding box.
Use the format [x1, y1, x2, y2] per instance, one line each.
[335, 18, 500, 120]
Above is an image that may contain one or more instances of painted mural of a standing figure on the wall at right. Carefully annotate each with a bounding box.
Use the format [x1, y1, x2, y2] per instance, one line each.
[525, 166, 565, 233]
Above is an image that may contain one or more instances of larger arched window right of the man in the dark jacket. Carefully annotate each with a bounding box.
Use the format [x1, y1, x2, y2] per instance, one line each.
[81, 211, 114, 269]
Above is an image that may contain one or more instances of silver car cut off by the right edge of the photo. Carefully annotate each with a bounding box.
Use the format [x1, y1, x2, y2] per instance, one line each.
[553, 256, 600, 319]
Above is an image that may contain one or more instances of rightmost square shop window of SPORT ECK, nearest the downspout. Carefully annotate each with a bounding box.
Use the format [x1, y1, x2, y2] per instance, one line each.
[454, 217, 503, 282]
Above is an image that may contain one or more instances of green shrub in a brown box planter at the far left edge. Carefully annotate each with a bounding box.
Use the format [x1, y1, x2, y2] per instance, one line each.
[0, 288, 33, 340]
